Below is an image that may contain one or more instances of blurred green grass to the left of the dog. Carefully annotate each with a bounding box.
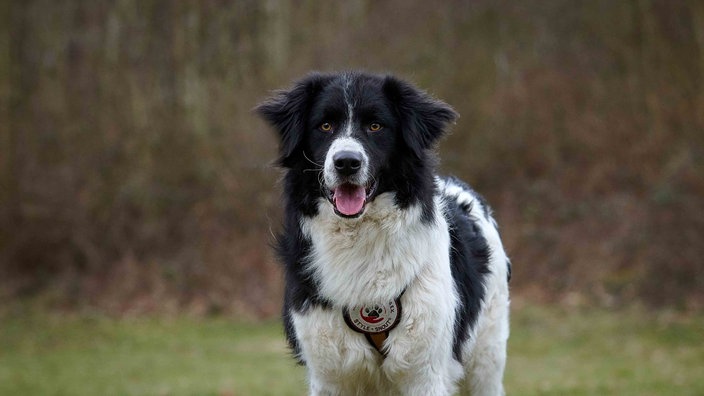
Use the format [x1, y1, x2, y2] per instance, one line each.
[0, 314, 305, 395]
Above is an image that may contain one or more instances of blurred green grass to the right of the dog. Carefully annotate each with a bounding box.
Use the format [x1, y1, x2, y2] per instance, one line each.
[506, 308, 704, 395]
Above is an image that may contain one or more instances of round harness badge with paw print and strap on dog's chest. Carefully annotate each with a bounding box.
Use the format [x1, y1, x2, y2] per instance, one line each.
[342, 293, 403, 356]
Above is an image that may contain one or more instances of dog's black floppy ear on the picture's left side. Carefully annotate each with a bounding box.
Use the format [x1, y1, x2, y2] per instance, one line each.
[254, 73, 329, 168]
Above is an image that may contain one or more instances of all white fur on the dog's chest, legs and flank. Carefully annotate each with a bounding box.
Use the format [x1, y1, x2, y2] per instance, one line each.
[293, 178, 508, 396]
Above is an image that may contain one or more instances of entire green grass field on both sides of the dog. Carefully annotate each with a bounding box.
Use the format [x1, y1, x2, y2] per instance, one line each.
[0, 307, 704, 396]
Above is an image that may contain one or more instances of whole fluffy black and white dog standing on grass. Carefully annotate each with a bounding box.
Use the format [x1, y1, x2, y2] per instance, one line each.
[256, 72, 510, 396]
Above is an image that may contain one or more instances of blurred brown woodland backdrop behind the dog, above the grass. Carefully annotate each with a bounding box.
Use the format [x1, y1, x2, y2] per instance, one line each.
[0, 0, 704, 319]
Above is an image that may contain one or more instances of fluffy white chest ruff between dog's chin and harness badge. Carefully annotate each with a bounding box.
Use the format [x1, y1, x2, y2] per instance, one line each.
[301, 193, 451, 307]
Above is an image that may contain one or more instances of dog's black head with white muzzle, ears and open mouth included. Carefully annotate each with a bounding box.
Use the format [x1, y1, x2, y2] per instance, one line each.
[256, 72, 457, 218]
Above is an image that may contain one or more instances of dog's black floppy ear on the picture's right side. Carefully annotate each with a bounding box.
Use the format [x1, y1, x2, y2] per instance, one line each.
[384, 76, 459, 158]
